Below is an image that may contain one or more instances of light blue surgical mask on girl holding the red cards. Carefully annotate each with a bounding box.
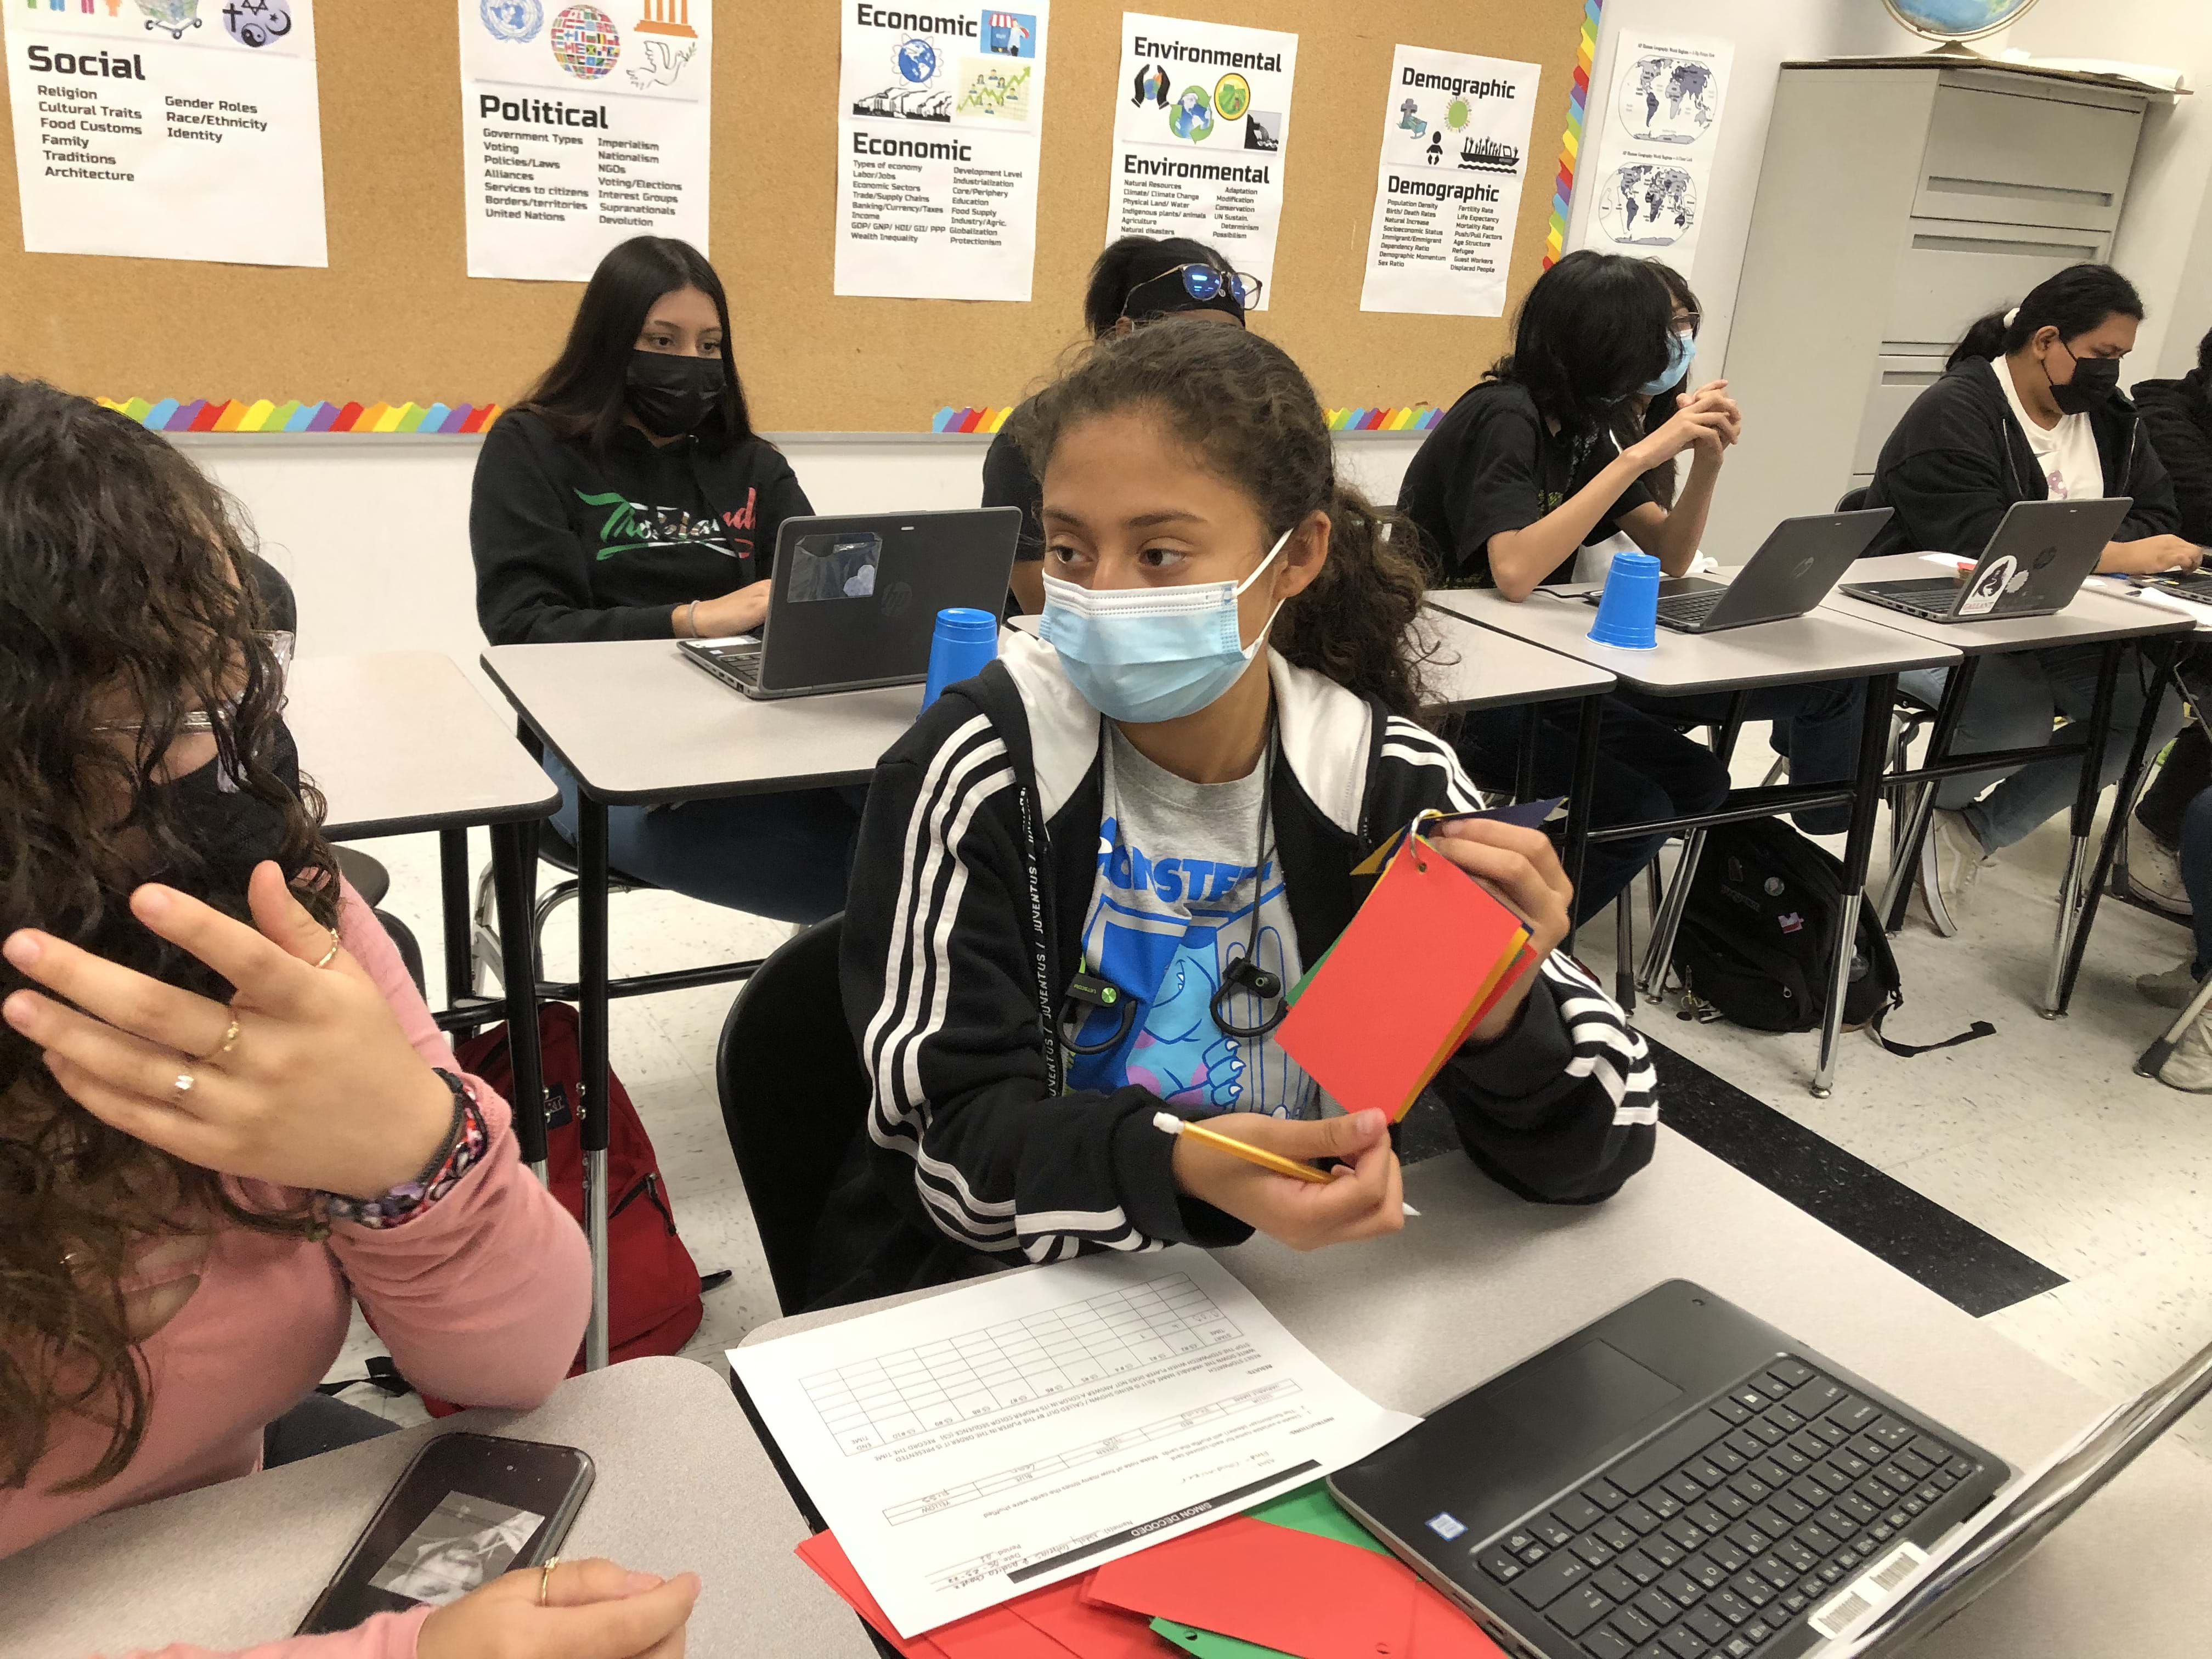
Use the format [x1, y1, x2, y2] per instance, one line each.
[1037, 531, 1290, 725]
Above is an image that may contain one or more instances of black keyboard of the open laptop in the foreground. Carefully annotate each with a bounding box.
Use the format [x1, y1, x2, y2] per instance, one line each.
[1475, 1358, 1976, 1659]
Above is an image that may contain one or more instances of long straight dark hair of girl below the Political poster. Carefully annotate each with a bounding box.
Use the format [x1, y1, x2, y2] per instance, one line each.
[515, 236, 752, 454]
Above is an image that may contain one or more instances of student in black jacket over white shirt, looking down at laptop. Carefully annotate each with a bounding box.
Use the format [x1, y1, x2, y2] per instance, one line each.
[1867, 266, 2199, 936]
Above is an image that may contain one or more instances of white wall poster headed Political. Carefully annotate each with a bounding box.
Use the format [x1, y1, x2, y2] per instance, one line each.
[458, 0, 714, 283]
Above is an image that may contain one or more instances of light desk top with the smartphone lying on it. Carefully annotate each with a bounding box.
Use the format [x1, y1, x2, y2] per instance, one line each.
[0, 1358, 874, 1659]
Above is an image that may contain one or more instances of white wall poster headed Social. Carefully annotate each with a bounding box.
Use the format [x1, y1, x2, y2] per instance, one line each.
[0, 0, 330, 266]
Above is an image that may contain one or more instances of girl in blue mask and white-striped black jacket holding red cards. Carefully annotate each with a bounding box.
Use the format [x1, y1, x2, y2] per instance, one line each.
[814, 319, 1657, 1303]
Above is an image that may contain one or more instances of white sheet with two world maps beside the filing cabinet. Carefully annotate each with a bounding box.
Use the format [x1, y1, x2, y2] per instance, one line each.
[1582, 36, 1736, 276]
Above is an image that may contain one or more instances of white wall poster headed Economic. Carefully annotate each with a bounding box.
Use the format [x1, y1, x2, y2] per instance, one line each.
[834, 0, 1051, 298]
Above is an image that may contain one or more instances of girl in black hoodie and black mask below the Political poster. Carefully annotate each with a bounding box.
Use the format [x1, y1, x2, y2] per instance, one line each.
[469, 236, 860, 922]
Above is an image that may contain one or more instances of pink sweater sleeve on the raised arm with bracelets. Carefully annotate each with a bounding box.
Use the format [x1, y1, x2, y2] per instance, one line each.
[330, 887, 591, 1407]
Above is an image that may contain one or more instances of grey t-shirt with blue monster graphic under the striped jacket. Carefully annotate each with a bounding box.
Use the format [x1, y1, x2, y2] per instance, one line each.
[1068, 723, 1338, 1117]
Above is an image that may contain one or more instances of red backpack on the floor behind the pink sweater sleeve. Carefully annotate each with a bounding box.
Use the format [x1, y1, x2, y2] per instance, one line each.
[404, 1002, 706, 1418]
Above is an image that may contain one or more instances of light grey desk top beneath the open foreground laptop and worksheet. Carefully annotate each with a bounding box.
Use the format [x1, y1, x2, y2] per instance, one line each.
[746, 1126, 2212, 1659]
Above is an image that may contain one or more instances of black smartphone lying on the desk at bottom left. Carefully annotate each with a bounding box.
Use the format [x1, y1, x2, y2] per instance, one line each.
[294, 1434, 593, 1637]
